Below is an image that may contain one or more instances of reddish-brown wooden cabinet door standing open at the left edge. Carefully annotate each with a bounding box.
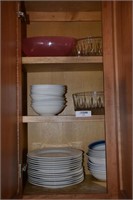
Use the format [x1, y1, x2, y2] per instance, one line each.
[0, 1, 20, 199]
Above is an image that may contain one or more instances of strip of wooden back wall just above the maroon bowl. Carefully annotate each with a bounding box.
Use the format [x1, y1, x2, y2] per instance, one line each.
[27, 21, 102, 38]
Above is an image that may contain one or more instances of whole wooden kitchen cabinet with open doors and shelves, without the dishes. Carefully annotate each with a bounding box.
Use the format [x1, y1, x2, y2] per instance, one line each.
[1, 1, 132, 199]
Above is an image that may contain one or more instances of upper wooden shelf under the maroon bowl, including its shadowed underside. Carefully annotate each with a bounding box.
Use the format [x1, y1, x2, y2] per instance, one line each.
[22, 56, 103, 72]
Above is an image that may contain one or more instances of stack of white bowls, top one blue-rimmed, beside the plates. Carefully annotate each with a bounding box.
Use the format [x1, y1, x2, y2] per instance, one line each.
[87, 140, 106, 181]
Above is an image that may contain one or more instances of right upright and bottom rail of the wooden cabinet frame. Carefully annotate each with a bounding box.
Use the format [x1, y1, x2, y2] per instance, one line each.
[17, 2, 119, 199]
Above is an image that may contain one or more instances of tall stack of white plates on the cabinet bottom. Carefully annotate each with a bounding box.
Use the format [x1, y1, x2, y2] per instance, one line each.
[27, 147, 84, 188]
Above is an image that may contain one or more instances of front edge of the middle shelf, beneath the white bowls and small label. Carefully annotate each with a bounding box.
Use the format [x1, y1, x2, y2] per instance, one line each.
[22, 115, 104, 123]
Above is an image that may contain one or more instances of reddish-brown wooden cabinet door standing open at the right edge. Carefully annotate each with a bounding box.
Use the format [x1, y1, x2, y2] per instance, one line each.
[114, 1, 133, 199]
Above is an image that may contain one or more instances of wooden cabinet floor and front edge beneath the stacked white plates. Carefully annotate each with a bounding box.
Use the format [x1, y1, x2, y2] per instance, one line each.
[23, 175, 107, 199]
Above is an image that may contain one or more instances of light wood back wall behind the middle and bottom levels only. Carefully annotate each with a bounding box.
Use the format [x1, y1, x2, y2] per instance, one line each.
[27, 71, 104, 166]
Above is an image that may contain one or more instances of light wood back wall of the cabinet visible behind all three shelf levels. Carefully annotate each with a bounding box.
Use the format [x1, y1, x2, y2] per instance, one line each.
[27, 22, 104, 157]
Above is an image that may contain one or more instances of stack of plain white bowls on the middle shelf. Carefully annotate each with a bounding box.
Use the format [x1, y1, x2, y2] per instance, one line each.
[30, 84, 67, 115]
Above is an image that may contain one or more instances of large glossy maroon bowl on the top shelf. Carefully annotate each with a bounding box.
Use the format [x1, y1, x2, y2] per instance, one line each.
[22, 36, 77, 56]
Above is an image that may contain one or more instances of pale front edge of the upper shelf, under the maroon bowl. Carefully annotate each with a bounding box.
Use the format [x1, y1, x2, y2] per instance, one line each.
[22, 56, 103, 64]
